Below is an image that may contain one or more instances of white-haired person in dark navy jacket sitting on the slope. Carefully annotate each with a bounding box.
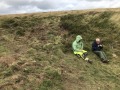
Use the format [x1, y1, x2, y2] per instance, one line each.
[92, 38, 109, 63]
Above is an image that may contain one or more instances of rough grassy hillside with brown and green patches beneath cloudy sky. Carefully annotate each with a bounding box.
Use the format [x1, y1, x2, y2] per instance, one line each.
[0, 9, 120, 90]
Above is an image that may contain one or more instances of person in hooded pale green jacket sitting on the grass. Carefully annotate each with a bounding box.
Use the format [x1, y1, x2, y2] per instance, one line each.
[72, 35, 92, 63]
